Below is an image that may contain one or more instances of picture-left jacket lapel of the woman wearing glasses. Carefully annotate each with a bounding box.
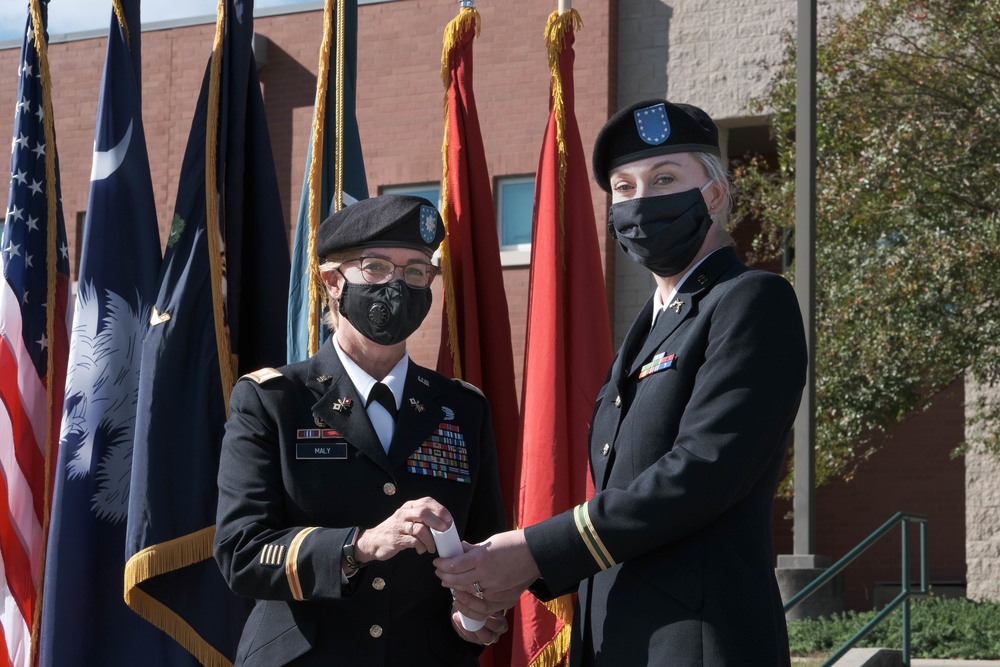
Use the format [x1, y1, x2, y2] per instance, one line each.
[306, 339, 399, 471]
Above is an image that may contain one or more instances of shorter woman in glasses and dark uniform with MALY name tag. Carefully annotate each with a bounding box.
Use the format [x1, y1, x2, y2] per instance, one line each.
[215, 195, 507, 667]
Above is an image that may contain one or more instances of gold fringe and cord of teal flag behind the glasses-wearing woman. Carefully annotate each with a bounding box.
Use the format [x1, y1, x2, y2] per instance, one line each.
[306, 0, 344, 356]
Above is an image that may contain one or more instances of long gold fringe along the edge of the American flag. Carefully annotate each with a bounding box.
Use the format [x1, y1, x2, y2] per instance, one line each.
[29, 0, 64, 665]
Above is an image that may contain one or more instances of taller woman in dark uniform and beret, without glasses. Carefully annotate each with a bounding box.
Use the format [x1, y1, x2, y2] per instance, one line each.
[436, 100, 806, 667]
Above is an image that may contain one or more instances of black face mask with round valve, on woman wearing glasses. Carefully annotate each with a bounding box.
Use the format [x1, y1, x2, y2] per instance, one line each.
[340, 280, 431, 345]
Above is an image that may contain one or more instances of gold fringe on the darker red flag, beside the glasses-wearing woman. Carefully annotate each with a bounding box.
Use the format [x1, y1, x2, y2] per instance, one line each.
[441, 7, 480, 379]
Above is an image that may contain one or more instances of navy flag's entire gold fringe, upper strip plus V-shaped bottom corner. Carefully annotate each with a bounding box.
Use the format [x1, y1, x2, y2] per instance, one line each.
[123, 0, 236, 667]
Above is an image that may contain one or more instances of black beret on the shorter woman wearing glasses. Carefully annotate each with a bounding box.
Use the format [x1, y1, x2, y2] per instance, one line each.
[316, 194, 444, 258]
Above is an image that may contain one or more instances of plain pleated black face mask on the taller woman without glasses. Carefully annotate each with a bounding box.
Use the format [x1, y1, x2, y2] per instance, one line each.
[608, 187, 712, 277]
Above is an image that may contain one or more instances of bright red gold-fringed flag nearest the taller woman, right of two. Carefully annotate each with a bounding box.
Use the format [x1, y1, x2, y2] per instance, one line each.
[510, 10, 612, 667]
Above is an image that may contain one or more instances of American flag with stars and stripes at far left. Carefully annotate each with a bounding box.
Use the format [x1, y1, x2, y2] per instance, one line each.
[0, 0, 69, 665]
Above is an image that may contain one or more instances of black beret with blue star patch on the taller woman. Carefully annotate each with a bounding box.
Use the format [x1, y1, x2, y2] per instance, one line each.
[593, 99, 721, 192]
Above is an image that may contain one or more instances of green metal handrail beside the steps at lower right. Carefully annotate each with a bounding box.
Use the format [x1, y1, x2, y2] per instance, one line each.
[785, 512, 928, 667]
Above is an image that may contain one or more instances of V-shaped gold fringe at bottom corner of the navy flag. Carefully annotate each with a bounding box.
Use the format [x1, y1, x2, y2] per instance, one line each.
[125, 526, 233, 667]
